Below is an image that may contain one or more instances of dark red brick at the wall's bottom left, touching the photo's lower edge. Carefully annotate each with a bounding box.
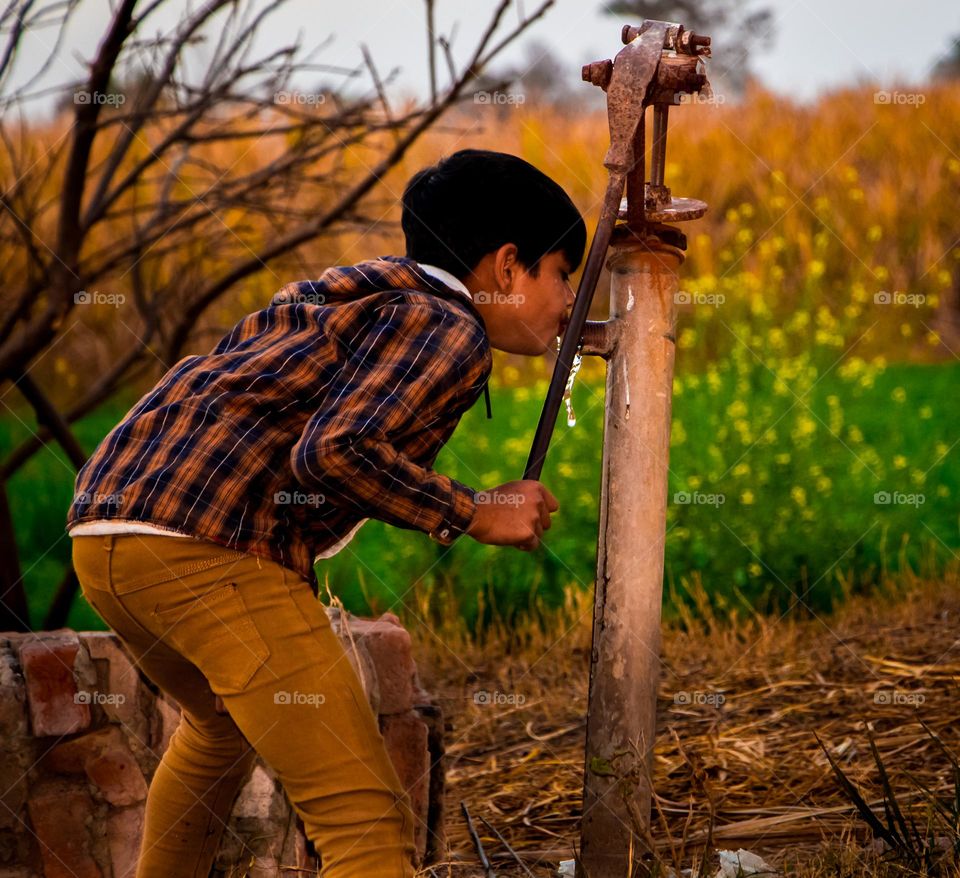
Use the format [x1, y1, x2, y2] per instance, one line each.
[27, 786, 103, 878]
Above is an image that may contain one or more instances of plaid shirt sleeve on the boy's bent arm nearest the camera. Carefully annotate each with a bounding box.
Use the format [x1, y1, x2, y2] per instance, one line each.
[290, 302, 489, 545]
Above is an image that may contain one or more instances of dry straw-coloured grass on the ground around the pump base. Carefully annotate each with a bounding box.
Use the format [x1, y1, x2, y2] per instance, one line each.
[408, 571, 960, 878]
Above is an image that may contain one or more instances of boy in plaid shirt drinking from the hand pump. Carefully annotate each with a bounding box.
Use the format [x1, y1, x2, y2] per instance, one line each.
[67, 150, 586, 878]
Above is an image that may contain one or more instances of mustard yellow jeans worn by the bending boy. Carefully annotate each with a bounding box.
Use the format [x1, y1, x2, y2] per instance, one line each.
[73, 533, 415, 878]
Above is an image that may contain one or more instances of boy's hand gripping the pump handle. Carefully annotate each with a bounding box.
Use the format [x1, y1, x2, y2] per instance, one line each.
[466, 479, 560, 552]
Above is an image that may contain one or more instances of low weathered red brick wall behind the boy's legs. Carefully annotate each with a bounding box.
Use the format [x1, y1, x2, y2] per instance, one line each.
[0, 608, 445, 878]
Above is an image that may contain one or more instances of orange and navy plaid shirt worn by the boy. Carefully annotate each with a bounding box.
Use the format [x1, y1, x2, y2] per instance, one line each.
[67, 256, 492, 590]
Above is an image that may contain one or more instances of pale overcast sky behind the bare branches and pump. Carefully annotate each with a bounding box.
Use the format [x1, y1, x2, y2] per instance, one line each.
[9, 0, 960, 114]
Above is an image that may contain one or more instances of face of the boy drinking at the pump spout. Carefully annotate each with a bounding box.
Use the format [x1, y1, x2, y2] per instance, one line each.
[464, 244, 575, 357]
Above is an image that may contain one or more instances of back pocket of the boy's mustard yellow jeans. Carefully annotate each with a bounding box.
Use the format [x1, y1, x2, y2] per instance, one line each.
[151, 582, 270, 695]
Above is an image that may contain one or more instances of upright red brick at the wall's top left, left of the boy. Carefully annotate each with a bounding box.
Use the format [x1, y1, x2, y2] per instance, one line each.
[20, 632, 90, 736]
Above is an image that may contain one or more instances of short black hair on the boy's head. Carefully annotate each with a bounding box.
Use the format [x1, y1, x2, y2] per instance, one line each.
[401, 149, 587, 280]
